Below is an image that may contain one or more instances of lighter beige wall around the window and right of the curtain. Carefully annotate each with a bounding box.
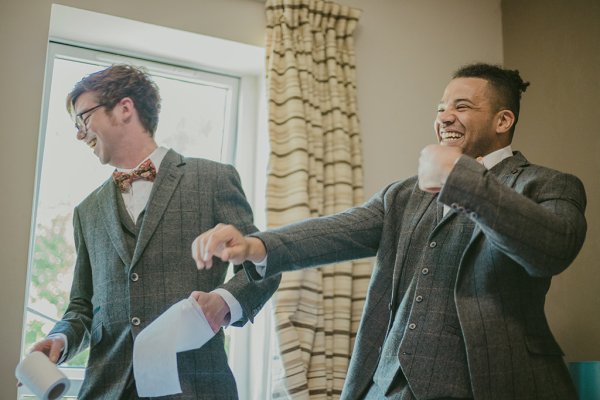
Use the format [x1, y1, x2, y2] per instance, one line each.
[0, 0, 504, 399]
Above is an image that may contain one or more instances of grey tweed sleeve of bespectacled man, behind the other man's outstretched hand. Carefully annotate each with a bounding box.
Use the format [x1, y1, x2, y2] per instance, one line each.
[215, 165, 281, 326]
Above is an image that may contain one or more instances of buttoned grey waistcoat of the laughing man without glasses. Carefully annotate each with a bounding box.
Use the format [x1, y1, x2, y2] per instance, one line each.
[373, 202, 475, 398]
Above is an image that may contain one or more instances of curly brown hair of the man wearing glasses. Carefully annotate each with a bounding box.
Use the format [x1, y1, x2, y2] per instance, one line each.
[67, 64, 160, 136]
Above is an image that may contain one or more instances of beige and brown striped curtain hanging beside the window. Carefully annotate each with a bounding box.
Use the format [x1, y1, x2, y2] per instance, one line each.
[266, 0, 371, 399]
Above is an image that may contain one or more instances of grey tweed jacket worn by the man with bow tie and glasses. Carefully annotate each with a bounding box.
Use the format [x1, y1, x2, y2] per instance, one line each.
[51, 150, 279, 400]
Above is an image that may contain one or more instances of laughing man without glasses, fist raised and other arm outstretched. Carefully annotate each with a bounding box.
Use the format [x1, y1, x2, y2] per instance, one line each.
[193, 64, 586, 400]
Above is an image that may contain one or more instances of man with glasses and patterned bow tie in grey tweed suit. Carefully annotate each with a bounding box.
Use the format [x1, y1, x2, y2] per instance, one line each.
[33, 65, 279, 400]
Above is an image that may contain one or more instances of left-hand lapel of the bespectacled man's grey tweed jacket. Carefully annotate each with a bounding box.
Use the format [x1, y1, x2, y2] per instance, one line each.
[98, 180, 131, 266]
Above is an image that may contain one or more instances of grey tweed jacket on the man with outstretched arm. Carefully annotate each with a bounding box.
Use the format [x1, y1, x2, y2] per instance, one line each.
[250, 152, 586, 400]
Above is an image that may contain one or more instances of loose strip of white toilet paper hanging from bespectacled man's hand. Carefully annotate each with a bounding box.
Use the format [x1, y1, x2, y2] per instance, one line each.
[133, 297, 215, 397]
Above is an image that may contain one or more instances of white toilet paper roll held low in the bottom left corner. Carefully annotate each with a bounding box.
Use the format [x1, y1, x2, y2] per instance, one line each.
[15, 351, 71, 400]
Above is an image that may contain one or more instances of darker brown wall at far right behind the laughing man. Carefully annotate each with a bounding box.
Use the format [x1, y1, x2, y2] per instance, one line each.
[502, 0, 600, 361]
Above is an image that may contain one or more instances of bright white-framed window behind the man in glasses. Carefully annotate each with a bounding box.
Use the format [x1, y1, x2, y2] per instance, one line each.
[20, 5, 270, 399]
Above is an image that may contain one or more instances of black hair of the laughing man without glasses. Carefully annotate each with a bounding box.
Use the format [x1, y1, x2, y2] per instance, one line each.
[452, 63, 529, 129]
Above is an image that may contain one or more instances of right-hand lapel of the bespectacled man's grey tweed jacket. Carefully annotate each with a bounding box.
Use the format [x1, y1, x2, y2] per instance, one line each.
[130, 150, 185, 268]
